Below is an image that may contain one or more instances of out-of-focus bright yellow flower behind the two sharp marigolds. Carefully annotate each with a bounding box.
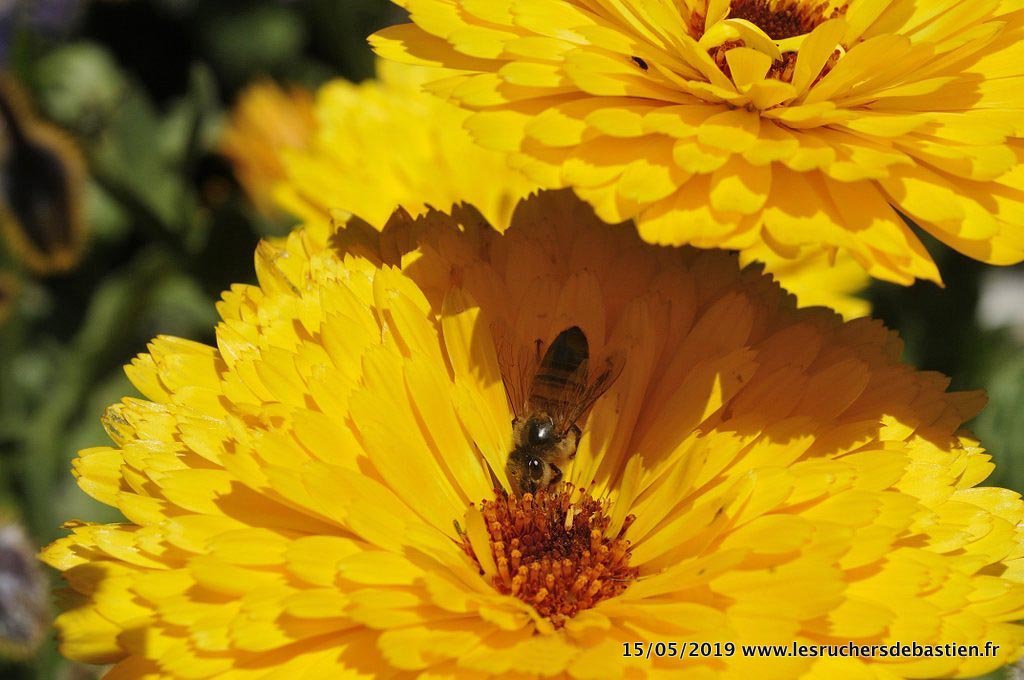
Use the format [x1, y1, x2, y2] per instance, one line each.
[278, 62, 535, 235]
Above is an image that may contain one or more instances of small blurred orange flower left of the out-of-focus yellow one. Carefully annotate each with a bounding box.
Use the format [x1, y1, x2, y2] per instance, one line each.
[220, 80, 316, 216]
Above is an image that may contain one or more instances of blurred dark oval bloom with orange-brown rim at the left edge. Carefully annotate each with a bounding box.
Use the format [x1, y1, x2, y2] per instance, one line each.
[0, 79, 85, 273]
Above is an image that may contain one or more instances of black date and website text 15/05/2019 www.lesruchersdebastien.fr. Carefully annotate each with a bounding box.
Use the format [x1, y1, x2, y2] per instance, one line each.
[623, 640, 999, 658]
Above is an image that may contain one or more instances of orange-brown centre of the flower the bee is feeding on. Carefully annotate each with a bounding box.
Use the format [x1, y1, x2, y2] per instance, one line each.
[463, 484, 639, 628]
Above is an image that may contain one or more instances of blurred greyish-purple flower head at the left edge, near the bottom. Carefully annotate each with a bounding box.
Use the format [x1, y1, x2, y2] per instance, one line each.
[0, 523, 49, 657]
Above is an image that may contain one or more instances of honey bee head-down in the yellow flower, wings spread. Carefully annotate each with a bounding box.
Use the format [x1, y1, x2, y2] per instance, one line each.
[502, 326, 622, 496]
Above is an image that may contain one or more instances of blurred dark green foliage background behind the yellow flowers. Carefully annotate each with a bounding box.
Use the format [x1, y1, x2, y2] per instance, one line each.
[0, 0, 1024, 679]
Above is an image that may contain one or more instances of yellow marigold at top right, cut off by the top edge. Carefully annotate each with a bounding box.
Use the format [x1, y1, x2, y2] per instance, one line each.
[373, 0, 1024, 284]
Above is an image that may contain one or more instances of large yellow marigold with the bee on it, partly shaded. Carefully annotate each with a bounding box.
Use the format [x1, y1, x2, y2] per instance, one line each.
[43, 192, 1024, 678]
